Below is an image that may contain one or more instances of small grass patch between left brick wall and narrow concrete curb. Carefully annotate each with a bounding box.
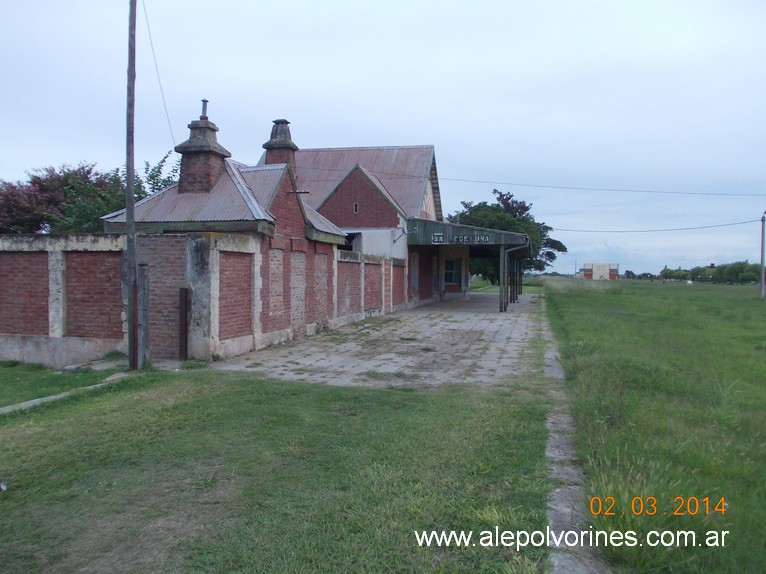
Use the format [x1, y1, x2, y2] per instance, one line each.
[0, 361, 122, 407]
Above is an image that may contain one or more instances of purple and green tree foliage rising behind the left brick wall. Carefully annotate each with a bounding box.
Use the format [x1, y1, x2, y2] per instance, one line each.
[0, 152, 180, 233]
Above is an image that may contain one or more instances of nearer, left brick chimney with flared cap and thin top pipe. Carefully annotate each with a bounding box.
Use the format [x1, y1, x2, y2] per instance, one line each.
[175, 100, 231, 193]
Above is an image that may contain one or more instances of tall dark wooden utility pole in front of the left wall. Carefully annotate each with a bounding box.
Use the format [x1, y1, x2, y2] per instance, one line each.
[125, 0, 138, 371]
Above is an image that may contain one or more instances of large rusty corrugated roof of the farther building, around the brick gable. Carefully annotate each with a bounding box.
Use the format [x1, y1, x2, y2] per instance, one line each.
[295, 146, 440, 217]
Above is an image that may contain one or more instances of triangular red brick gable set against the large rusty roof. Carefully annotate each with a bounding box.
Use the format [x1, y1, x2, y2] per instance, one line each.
[319, 169, 399, 227]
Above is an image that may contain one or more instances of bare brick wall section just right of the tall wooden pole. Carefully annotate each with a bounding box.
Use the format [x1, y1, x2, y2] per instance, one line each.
[137, 235, 188, 359]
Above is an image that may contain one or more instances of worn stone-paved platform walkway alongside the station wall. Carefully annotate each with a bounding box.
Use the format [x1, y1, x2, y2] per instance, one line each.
[211, 293, 541, 387]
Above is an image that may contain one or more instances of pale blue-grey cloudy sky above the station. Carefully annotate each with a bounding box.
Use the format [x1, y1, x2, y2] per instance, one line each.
[0, 0, 766, 273]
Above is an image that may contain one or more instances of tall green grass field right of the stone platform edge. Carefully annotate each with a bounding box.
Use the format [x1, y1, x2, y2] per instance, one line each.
[545, 282, 766, 573]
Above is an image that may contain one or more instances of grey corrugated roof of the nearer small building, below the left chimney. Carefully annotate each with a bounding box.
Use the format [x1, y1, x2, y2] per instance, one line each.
[102, 160, 285, 227]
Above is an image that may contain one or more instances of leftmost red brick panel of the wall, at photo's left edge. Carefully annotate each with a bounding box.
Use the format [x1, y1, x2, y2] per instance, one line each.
[0, 252, 48, 335]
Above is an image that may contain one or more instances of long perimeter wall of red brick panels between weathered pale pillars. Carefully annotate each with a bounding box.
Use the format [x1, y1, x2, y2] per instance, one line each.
[0, 233, 414, 367]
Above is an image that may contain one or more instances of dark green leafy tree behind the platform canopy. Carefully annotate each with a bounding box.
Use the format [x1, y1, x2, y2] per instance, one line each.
[447, 189, 567, 274]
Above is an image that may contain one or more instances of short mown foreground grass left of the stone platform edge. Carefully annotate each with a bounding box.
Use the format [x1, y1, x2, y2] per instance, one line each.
[0, 369, 552, 573]
